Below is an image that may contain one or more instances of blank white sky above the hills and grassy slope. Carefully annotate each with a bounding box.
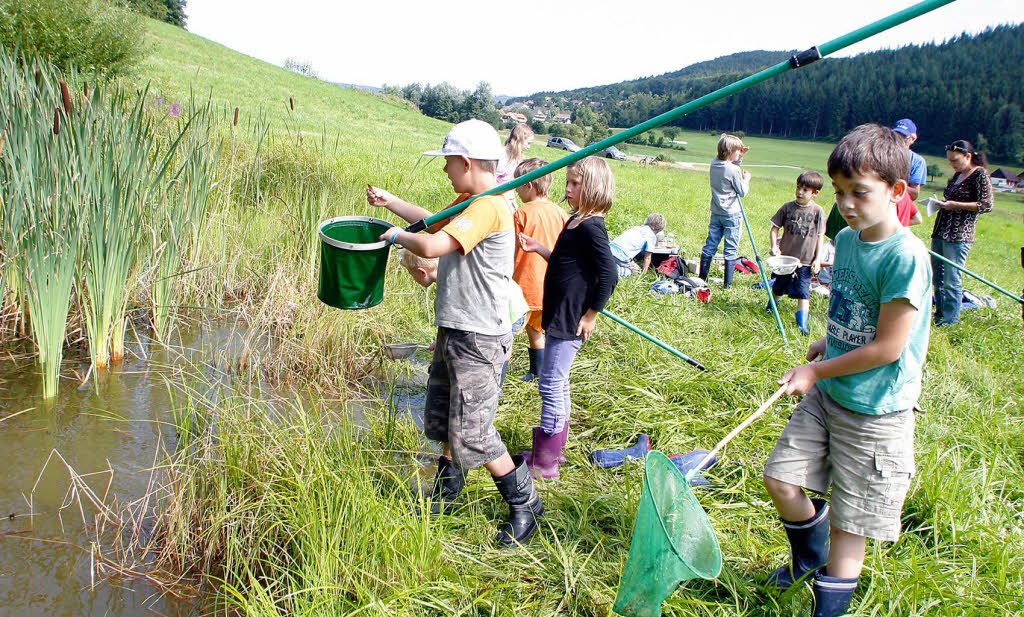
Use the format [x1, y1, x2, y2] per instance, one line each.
[185, 0, 1024, 95]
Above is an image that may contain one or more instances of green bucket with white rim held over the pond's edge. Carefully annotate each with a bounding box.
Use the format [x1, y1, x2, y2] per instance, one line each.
[316, 216, 392, 309]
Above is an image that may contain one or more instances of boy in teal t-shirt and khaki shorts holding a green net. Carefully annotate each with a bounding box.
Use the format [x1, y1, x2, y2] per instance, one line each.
[764, 125, 932, 617]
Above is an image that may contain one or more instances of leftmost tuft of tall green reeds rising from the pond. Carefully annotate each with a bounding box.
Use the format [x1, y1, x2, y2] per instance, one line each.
[0, 53, 83, 398]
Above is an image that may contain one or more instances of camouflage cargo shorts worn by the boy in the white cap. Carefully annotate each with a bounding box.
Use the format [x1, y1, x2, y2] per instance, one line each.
[423, 327, 512, 470]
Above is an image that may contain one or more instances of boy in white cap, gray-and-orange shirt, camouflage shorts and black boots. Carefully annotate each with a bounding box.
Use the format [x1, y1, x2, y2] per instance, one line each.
[367, 120, 544, 546]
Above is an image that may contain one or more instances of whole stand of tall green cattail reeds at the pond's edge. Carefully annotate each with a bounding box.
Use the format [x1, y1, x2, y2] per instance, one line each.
[0, 48, 219, 397]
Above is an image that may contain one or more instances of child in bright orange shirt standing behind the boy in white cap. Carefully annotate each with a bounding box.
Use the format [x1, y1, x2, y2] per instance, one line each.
[512, 159, 568, 382]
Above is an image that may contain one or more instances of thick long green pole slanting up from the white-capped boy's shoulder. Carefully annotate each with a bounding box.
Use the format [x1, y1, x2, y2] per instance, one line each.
[406, 0, 955, 232]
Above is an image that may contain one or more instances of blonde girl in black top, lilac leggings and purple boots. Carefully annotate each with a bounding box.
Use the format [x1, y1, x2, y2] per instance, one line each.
[519, 157, 618, 479]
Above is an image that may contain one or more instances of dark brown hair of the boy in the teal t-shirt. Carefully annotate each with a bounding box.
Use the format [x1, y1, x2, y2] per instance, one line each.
[828, 124, 910, 186]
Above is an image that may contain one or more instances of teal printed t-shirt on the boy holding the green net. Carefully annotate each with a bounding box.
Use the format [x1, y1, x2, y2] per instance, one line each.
[818, 227, 932, 415]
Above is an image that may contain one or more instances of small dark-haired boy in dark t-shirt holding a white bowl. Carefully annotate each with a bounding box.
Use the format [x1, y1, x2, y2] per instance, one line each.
[767, 171, 825, 335]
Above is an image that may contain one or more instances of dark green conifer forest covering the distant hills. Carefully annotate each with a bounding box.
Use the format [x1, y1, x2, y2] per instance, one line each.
[520, 25, 1024, 163]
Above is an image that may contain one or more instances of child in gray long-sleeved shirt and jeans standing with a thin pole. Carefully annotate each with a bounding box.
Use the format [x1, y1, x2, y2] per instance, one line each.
[700, 133, 751, 288]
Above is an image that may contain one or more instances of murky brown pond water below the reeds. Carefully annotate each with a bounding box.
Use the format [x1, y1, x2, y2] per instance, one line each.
[0, 327, 425, 617]
